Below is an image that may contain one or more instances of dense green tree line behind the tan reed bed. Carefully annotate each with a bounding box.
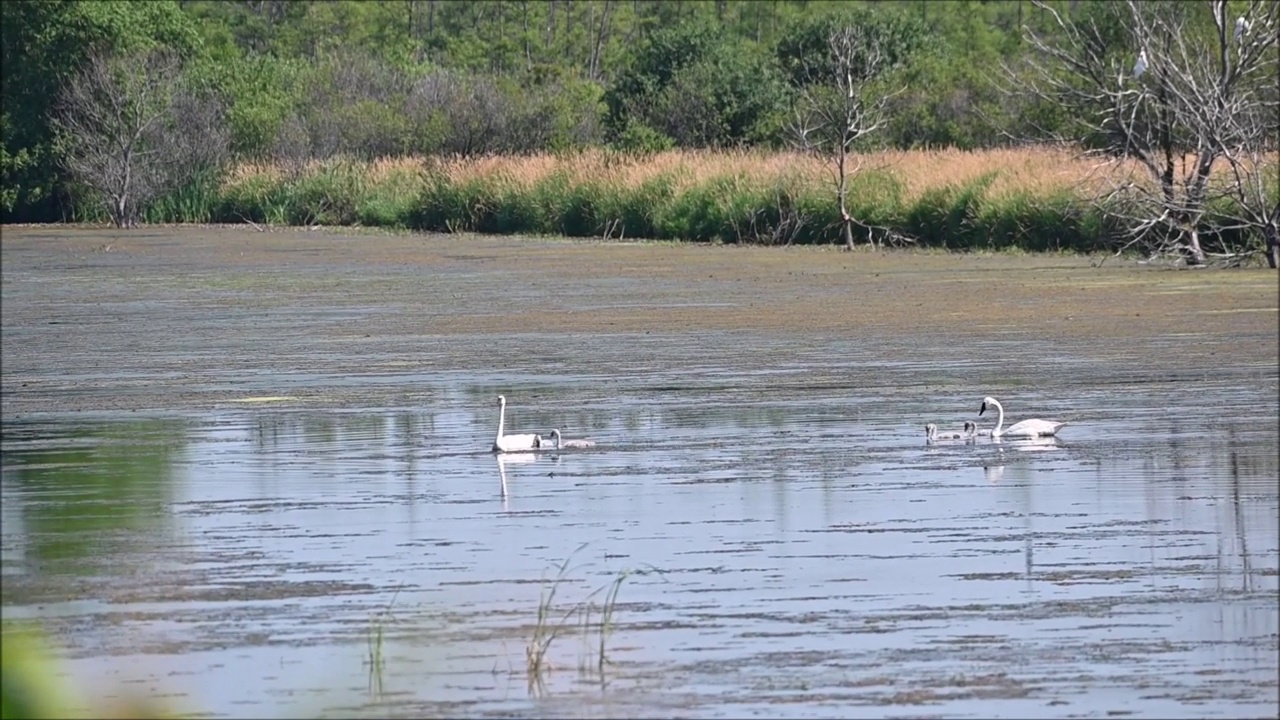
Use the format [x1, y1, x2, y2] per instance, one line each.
[0, 0, 1089, 222]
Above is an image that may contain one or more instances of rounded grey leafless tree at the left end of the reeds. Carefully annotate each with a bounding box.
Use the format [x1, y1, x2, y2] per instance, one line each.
[54, 51, 228, 228]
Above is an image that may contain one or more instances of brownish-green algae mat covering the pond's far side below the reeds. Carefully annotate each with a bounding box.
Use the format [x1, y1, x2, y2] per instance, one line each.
[0, 227, 1280, 419]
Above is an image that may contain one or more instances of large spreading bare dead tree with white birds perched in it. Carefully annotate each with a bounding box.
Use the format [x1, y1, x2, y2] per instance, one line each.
[1007, 0, 1280, 265]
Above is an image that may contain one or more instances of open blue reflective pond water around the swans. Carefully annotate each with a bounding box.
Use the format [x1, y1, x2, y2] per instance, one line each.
[3, 351, 1280, 717]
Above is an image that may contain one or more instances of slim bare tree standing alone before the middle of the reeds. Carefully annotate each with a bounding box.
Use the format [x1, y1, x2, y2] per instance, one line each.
[791, 26, 897, 250]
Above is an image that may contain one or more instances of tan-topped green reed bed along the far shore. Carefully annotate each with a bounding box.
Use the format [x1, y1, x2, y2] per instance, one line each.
[140, 147, 1269, 251]
